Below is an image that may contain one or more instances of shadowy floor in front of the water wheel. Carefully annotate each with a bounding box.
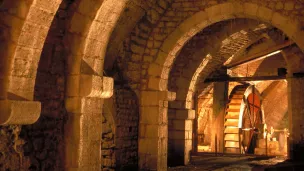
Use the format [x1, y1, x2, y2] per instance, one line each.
[168, 155, 287, 171]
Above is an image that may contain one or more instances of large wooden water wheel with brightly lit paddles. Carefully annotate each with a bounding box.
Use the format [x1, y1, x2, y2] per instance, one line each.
[224, 85, 264, 154]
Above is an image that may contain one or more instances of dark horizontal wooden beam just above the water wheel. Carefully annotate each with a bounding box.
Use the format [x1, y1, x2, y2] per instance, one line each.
[204, 75, 286, 83]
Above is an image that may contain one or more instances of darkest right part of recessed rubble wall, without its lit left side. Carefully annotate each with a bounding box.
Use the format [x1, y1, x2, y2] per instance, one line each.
[114, 85, 139, 170]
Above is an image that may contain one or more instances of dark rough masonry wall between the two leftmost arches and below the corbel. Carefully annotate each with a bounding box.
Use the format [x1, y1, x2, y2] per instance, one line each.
[0, 1, 71, 171]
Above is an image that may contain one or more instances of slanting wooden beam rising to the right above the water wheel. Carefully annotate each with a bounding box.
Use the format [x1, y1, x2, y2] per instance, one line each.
[227, 40, 294, 69]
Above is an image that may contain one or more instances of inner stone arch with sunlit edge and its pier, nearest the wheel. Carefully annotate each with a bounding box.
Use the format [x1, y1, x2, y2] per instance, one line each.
[168, 20, 269, 166]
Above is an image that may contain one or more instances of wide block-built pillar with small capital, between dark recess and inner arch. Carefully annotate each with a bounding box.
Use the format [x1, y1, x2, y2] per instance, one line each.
[138, 91, 176, 171]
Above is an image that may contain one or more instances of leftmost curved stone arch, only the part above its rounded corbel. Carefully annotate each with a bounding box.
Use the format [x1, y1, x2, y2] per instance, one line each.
[1, 0, 61, 100]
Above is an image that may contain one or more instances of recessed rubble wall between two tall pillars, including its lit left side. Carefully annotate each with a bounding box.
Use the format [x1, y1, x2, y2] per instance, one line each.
[101, 85, 139, 171]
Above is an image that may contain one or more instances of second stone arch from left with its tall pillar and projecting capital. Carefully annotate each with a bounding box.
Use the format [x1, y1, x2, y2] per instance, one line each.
[64, 0, 128, 170]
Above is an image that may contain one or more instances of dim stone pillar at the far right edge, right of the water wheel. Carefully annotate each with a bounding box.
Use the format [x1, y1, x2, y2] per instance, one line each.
[283, 46, 304, 161]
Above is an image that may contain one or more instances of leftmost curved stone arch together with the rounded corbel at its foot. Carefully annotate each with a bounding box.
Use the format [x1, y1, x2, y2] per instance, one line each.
[0, 0, 61, 124]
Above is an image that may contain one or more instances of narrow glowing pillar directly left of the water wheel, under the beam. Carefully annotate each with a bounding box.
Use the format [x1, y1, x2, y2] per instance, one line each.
[211, 82, 228, 153]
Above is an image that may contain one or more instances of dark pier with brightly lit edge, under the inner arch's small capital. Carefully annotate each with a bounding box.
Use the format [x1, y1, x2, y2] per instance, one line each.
[168, 109, 195, 166]
